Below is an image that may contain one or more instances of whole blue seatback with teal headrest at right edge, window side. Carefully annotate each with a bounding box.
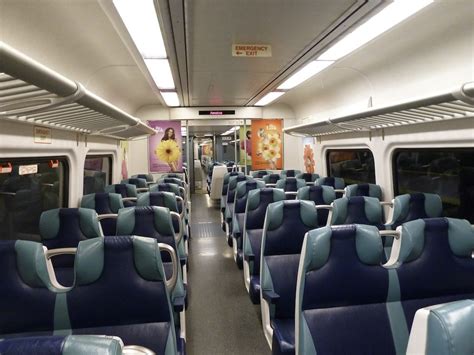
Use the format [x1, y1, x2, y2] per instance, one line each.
[393, 218, 474, 340]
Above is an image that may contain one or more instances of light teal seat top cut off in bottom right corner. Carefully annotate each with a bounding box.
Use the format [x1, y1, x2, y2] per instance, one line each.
[407, 300, 474, 355]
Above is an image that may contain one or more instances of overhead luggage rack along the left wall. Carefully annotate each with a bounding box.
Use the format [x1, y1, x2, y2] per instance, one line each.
[0, 42, 155, 139]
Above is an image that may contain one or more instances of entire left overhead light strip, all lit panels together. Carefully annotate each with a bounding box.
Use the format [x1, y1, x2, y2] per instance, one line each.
[113, 0, 179, 106]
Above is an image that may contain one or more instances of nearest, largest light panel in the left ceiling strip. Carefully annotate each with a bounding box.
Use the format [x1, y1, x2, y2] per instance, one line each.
[113, 0, 167, 58]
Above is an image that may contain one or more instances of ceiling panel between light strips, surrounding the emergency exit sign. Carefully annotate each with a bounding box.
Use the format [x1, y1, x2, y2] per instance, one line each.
[186, 0, 356, 106]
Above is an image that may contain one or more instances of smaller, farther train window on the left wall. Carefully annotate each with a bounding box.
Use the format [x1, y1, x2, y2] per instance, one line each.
[83, 155, 112, 195]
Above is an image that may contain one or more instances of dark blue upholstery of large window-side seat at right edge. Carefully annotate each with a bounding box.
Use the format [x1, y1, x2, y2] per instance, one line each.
[397, 218, 474, 329]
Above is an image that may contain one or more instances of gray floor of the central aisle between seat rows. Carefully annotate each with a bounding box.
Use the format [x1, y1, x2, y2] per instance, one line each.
[186, 194, 271, 355]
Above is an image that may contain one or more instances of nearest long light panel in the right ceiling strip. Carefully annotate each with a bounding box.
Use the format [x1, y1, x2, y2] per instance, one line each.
[317, 0, 433, 61]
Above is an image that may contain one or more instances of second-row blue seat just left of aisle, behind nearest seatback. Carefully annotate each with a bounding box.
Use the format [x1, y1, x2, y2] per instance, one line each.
[117, 206, 186, 310]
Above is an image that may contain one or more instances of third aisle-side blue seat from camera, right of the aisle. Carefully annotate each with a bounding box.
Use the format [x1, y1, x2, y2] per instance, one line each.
[242, 187, 285, 304]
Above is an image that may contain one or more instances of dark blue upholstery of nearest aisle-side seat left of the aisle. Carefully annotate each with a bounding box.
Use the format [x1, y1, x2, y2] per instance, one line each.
[67, 237, 176, 354]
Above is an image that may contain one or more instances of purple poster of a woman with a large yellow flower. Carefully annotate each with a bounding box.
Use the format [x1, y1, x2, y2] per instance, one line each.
[148, 121, 183, 173]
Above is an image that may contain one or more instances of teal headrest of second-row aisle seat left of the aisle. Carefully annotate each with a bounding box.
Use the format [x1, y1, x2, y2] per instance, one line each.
[117, 206, 174, 235]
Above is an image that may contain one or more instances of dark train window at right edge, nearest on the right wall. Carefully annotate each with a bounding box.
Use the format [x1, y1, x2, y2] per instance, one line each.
[393, 148, 474, 223]
